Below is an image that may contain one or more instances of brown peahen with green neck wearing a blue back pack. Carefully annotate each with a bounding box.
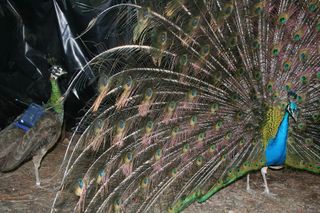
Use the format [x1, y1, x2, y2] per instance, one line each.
[0, 65, 66, 186]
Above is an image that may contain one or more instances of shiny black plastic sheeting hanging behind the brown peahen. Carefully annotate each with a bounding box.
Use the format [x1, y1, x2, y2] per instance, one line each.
[0, 0, 130, 129]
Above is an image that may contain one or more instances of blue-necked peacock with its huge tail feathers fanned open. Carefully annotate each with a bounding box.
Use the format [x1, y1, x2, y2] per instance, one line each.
[51, 0, 320, 213]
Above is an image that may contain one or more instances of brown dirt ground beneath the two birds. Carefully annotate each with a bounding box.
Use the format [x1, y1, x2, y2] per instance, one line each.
[0, 139, 320, 213]
